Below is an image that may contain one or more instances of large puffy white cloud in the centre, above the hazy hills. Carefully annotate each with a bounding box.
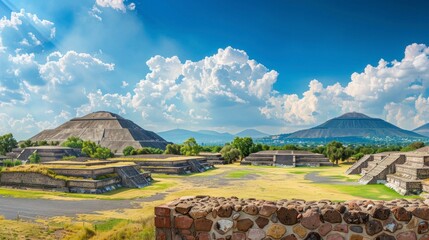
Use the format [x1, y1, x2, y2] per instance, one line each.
[126, 47, 278, 123]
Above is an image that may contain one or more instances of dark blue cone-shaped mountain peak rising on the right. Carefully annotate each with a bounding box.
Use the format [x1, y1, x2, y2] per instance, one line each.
[285, 112, 424, 139]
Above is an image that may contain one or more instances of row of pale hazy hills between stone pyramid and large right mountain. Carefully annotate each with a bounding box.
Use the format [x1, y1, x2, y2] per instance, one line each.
[158, 129, 269, 144]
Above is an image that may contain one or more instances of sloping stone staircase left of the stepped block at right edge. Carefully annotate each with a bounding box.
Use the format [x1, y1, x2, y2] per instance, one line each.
[359, 154, 405, 184]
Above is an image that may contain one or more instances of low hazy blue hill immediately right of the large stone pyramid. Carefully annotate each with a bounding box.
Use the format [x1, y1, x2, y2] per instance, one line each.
[158, 128, 234, 144]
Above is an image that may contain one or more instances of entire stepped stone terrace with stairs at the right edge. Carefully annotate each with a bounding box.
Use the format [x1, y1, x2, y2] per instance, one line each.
[346, 147, 429, 195]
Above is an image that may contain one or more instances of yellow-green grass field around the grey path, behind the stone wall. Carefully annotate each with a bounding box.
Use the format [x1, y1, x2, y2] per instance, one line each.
[0, 164, 418, 239]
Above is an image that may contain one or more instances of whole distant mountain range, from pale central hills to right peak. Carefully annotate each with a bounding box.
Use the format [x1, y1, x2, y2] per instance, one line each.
[158, 112, 429, 145]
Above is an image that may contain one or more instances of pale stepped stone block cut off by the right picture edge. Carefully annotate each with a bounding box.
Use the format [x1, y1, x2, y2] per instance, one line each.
[386, 153, 429, 195]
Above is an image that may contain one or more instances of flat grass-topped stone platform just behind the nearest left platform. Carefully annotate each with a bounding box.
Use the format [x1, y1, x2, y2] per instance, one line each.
[111, 154, 213, 174]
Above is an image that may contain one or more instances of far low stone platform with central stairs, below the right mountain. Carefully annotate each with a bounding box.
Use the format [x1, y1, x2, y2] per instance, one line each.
[241, 150, 333, 167]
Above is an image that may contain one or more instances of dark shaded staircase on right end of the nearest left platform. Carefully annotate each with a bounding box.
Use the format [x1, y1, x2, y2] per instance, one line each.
[117, 166, 152, 188]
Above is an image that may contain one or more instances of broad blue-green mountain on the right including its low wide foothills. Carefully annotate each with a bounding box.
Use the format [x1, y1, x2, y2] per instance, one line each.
[264, 112, 429, 143]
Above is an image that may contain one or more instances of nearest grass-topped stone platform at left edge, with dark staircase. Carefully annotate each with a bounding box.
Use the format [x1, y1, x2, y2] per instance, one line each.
[0, 160, 152, 193]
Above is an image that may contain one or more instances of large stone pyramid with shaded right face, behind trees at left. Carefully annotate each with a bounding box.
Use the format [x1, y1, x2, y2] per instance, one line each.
[30, 111, 169, 153]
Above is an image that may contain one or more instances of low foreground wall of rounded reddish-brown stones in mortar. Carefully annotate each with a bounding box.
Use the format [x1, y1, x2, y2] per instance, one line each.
[155, 196, 429, 240]
